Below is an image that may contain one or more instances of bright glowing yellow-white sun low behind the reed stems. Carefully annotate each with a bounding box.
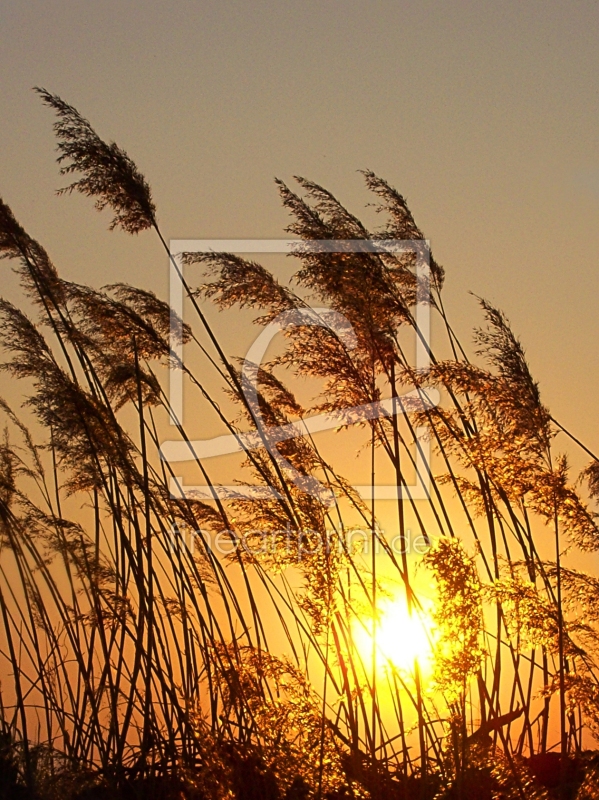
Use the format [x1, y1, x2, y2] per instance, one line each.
[354, 594, 433, 674]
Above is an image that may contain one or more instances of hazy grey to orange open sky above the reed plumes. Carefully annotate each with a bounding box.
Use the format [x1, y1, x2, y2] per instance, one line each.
[0, 0, 599, 468]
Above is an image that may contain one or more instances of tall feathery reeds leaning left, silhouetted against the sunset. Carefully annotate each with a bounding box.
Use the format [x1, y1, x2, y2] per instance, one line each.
[0, 90, 599, 800]
